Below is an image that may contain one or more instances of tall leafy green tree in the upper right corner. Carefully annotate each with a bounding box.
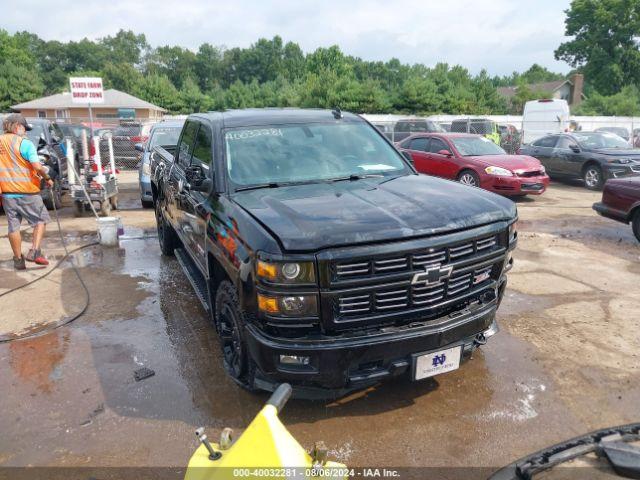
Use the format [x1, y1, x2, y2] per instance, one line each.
[555, 0, 640, 95]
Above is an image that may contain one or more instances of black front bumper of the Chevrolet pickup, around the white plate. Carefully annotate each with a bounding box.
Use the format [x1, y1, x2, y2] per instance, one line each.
[246, 296, 505, 397]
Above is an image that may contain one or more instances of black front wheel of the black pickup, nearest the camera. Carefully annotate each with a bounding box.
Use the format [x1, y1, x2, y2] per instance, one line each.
[214, 280, 255, 389]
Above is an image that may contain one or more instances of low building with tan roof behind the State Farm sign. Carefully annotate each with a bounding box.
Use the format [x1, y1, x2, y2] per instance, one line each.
[11, 89, 166, 123]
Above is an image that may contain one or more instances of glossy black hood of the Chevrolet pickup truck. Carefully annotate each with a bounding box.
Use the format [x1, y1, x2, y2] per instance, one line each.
[233, 175, 516, 251]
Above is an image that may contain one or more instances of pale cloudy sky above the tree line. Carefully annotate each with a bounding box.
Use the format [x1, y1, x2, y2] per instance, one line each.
[5, 0, 569, 75]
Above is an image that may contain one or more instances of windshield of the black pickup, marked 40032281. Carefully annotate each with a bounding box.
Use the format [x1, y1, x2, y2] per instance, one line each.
[225, 122, 410, 186]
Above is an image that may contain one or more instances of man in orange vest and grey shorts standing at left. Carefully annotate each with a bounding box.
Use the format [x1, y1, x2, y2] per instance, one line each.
[0, 114, 53, 270]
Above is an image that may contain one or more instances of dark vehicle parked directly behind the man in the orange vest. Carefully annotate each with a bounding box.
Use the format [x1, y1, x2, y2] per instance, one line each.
[27, 118, 69, 210]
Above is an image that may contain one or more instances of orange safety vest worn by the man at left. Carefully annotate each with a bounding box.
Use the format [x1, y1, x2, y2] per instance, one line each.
[0, 133, 40, 195]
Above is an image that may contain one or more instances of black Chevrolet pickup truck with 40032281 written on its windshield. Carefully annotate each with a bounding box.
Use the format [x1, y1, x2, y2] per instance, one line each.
[151, 109, 517, 396]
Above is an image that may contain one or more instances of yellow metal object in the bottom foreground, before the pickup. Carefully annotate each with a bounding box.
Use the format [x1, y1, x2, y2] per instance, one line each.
[185, 404, 347, 480]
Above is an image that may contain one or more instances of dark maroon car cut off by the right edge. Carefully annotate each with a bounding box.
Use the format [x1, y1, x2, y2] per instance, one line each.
[593, 177, 640, 242]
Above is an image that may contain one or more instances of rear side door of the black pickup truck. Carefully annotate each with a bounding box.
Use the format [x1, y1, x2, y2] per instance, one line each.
[167, 120, 198, 242]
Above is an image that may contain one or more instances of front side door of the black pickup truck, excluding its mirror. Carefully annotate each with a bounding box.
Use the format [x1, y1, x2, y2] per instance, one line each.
[182, 123, 214, 272]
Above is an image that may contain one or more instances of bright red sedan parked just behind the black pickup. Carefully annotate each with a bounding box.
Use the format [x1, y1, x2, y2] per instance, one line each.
[398, 133, 549, 196]
